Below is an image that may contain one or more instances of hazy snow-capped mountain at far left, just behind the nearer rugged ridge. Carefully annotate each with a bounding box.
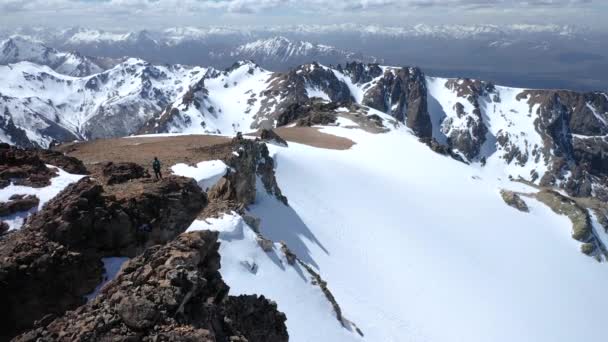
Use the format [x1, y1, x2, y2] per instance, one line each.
[0, 37, 112, 77]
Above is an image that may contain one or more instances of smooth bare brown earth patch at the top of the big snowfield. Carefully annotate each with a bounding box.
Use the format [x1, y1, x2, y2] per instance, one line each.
[250, 127, 355, 150]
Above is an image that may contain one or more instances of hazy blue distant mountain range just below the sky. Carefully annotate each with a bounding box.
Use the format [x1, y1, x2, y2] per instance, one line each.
[0, 24, 608, 91]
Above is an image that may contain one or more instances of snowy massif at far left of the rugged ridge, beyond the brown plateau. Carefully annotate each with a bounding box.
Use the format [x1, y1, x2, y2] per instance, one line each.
[0, 59, 205, 146]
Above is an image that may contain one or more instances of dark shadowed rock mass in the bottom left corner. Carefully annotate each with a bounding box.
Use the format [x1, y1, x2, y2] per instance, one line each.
[0, 230, 103, 341]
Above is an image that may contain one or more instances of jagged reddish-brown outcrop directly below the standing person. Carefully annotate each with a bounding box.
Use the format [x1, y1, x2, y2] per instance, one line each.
[24, 177, 207, 257]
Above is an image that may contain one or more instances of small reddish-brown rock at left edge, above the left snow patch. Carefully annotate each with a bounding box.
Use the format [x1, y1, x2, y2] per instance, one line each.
[0, 143, 57, 188]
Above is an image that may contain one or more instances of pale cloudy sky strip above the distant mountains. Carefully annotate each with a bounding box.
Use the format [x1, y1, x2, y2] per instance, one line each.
[0, 0, 608, 30]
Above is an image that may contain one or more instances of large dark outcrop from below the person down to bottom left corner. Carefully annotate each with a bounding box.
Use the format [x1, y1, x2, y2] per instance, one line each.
[0, 172, 207, 336]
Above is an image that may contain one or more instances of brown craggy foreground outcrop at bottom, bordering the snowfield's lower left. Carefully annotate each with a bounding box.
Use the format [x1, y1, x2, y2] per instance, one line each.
[15, 231, 288, 342]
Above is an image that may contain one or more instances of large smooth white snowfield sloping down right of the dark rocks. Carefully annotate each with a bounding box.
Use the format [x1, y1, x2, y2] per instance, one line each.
[178, 127, 608, 342]
